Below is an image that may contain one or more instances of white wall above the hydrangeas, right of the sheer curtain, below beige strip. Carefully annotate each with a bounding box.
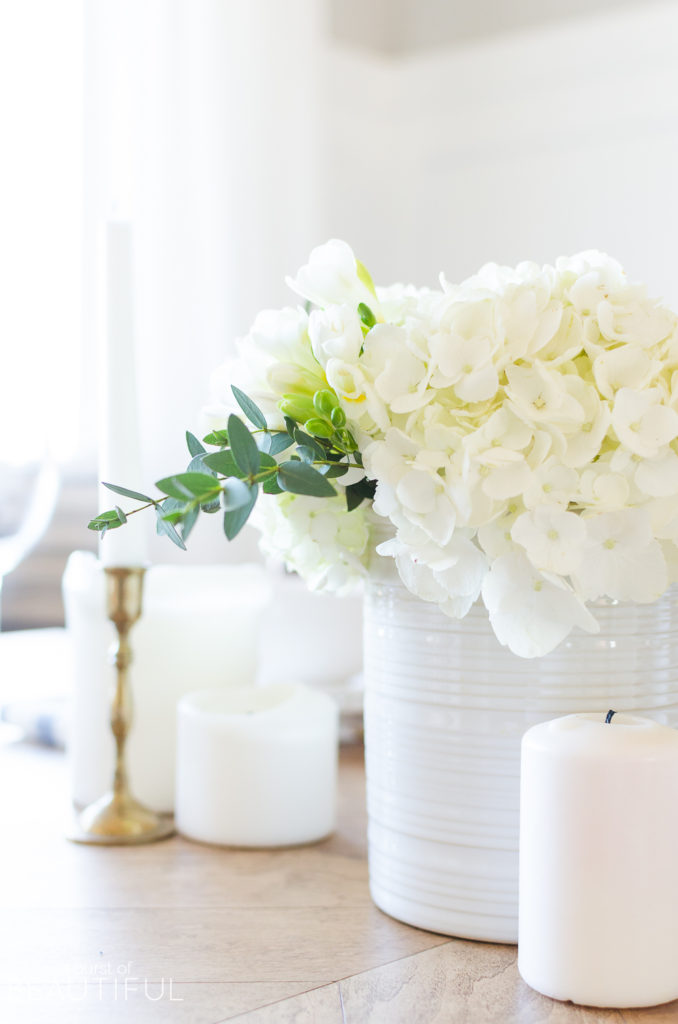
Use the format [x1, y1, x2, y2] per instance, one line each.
[322, 3, 678, 302]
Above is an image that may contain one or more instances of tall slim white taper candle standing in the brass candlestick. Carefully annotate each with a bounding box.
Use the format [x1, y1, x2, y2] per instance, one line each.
[98, 221, 149, 566]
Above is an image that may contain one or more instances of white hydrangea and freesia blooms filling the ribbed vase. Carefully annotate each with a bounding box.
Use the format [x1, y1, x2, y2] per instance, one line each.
[209, 241, 678, 657]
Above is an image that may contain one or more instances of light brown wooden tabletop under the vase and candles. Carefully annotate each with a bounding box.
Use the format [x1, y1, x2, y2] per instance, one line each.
[0, 744, 678, 1024]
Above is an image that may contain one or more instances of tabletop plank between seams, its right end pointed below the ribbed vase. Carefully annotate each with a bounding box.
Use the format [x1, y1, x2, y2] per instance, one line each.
[0, 906, 446, 985]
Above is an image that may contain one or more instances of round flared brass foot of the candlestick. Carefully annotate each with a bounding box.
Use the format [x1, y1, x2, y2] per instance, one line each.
[68, 793, 174, 846]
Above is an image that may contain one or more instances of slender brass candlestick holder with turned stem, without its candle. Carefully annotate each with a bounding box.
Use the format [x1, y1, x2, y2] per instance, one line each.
[69, 568, 174, 846]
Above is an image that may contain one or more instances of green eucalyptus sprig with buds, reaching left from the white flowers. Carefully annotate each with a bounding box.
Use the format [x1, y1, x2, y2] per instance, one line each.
[88, 386, 375, 550]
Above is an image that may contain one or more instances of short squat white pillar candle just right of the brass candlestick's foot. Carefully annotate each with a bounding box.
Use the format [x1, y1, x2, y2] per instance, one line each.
[176, 684, 338, 847]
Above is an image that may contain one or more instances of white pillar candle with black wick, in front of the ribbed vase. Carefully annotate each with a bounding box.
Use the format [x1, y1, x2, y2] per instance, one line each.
[518, 713, 678, 1008]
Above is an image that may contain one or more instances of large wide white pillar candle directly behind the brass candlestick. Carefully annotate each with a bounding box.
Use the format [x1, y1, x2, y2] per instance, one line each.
[63, 551, 270, 812]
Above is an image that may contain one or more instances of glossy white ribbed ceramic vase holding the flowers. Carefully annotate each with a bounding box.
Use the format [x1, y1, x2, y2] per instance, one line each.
[365, 558, 678, 942]
